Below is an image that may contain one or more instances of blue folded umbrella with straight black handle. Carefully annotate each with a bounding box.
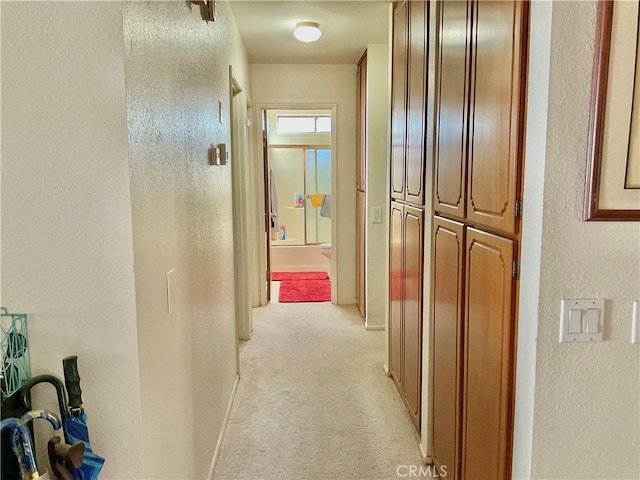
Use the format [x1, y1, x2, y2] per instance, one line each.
[62, 355, 104, 480]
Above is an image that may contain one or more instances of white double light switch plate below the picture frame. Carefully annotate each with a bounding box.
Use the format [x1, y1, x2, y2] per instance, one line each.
[559, 299, 604, 342]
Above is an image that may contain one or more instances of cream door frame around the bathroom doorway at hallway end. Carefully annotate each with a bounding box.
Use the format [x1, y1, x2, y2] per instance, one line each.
[250, 103, 340, 305]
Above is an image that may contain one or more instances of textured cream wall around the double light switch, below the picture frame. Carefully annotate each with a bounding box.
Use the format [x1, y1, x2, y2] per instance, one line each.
[516, 2, 640, 479]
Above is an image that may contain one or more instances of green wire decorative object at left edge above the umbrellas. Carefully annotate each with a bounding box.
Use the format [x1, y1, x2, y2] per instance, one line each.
[0, 307, 31, 400]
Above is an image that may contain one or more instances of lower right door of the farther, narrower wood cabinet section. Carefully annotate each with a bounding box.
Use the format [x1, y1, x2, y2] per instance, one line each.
[402, 205, 424, 430]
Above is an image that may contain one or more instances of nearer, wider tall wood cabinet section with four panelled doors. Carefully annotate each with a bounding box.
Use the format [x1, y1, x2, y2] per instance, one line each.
[430, 0, 528, 480]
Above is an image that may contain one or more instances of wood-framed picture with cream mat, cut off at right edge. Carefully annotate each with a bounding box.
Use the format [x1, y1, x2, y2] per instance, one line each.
[583, 0, 640, 221]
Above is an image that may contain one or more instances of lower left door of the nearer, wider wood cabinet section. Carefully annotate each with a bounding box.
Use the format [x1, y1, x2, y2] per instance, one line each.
[430, 217, 465, 480]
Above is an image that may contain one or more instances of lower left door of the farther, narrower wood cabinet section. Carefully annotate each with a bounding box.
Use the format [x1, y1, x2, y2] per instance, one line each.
[389, 202, 404, 392]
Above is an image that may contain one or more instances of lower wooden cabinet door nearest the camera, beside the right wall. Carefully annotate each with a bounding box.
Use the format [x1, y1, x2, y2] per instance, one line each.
[462, 228, 516, 479]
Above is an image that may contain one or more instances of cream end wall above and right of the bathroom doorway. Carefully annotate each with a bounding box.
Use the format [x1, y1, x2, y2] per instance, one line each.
[251, 64, 356, 303]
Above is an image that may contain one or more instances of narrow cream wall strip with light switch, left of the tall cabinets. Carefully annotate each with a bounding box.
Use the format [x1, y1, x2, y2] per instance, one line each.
[366, 43, 389, 328]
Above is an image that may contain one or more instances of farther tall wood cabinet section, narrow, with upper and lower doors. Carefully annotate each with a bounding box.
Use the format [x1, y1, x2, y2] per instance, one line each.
[389, 1, 429, 430]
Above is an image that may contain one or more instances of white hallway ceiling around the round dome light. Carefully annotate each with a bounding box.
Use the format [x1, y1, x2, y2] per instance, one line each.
[229, 0, 391, 64]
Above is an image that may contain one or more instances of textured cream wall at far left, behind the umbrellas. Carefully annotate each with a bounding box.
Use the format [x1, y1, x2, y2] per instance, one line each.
[1, 2, 143, 479]
